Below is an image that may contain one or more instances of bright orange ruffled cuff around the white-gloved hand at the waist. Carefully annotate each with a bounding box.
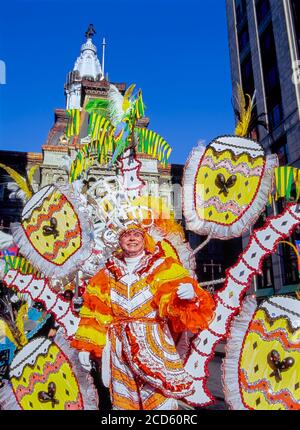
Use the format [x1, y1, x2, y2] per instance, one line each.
[154, 278, 216, 333]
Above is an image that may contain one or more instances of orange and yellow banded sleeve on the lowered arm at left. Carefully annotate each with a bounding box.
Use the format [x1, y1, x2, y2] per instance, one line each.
[71, 269, 113, 358]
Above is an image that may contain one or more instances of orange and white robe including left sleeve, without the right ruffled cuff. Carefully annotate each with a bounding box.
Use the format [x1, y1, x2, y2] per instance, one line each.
[72, 248, 197, 410]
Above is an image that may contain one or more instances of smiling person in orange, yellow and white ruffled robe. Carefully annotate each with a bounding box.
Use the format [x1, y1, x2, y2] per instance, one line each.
[73, 224, 215, 410]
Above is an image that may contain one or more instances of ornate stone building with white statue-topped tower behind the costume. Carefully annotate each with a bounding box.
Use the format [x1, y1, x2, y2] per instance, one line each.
[0, 30, 173, 230]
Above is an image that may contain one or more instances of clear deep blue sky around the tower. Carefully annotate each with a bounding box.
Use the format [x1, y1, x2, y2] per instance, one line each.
[0, 0, 234, 164]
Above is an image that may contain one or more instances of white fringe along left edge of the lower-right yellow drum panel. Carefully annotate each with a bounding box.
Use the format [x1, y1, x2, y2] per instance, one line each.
[222, 296, 257, 410]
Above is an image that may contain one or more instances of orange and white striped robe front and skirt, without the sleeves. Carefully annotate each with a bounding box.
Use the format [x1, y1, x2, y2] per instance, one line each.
[109, 275, 192, 410]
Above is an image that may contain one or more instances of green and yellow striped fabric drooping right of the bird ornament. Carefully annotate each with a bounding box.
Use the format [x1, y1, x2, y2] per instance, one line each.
[135, 127, 172, 165]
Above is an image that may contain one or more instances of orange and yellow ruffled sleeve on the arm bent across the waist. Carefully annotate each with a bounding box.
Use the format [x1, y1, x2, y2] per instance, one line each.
[149, 258, 216, 333]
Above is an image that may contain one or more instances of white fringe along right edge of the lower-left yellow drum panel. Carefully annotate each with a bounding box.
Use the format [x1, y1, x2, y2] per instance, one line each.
[54, 330, 99, 411]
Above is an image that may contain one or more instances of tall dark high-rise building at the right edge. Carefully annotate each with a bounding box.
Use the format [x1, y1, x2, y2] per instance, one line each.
[226, 0, 300, 294]
